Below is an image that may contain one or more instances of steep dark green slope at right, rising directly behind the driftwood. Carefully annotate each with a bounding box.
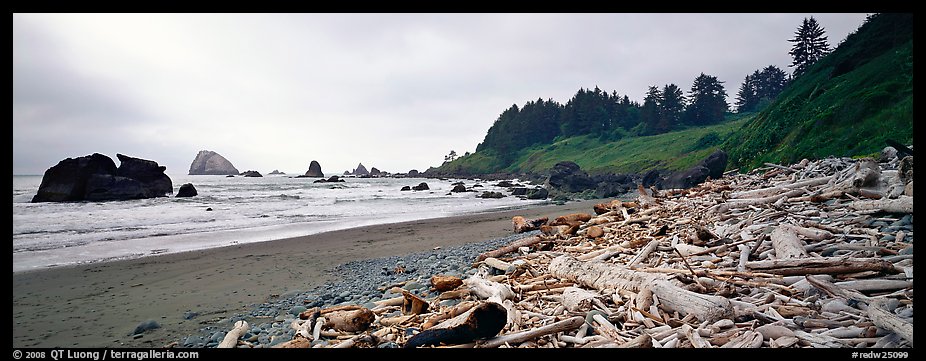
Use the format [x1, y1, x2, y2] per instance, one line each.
[722, 14, 913, 169]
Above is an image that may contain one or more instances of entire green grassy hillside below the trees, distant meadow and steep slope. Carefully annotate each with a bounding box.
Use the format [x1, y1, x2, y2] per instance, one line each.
[430, 14, 913, 175]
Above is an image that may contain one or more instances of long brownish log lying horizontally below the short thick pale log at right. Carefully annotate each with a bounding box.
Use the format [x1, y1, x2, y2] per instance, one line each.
[746, 257, 897, 276]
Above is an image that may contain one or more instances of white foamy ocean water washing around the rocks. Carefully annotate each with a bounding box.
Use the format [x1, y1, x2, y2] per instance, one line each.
[13, 175, 548, 272]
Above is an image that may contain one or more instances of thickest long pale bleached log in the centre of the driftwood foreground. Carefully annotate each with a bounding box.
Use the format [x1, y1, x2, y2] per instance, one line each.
[549, 255, 733, 321]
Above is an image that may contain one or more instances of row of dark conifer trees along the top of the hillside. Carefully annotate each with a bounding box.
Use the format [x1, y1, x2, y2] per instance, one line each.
[472, 17, 830, 162]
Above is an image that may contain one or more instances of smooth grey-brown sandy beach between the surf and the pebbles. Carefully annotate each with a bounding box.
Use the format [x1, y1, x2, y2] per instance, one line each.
[13, 201, 597, 348]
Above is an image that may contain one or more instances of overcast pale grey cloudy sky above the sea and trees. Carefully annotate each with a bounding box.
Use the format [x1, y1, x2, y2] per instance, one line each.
[13, 13, 865, 174]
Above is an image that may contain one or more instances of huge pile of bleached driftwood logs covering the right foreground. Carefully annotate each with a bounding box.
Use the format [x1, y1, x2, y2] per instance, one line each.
[220, 151, 913, 348]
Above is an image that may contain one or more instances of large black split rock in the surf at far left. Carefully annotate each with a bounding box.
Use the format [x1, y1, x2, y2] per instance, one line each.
[32, 153, 174, 202]
